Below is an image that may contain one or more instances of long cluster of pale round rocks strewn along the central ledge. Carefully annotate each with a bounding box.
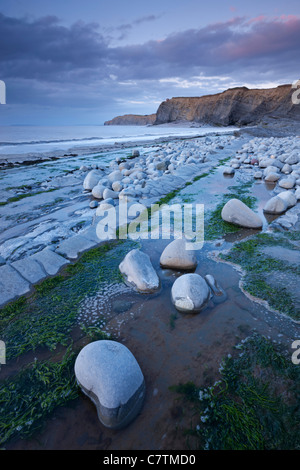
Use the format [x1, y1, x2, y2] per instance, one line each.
[80, 136, 234, 211]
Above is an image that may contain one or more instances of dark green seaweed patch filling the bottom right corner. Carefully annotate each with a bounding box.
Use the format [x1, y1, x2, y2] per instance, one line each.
[172, 334, 300, 450]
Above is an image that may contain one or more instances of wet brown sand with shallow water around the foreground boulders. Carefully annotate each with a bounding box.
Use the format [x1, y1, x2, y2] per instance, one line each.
[6, 237, 298, 450]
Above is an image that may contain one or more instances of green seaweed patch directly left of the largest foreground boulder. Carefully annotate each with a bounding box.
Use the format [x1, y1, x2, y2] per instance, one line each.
[0, 347, 78, 445]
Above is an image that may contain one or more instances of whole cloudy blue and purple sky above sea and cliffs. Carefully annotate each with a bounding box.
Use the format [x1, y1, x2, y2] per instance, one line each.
[0, 0, 300, 125]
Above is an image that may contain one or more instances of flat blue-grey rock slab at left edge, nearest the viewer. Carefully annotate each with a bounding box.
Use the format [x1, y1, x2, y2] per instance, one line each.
[0, 264, 31, 307]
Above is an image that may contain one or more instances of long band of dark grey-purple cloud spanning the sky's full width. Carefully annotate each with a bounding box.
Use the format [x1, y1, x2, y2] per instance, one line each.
[0, 14, 300, 81]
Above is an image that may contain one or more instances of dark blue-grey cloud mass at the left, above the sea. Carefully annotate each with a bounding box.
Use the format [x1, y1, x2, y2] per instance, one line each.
[0, 14, 108, 80]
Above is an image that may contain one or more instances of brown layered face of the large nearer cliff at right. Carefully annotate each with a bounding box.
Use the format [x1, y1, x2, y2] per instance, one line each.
[154, 85, 300, 126]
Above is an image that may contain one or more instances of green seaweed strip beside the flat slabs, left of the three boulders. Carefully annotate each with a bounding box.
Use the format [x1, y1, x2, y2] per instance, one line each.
[0, 241, 135, 360]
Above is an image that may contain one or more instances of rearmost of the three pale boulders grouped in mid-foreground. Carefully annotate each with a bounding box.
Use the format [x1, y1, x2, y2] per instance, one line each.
[160, 238, 197, 270]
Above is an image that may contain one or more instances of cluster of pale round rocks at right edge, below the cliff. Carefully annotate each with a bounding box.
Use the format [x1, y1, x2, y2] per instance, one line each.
[224, 137, 300, 215]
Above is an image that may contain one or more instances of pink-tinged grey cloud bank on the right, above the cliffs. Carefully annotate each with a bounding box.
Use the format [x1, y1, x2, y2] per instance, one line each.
[113, 17, 300, 78]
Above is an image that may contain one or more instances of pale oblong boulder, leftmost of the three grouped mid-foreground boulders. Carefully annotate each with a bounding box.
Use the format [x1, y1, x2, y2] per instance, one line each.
[119, 249, 160, 293]
